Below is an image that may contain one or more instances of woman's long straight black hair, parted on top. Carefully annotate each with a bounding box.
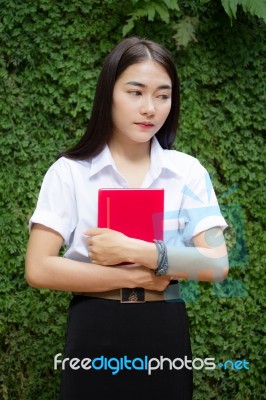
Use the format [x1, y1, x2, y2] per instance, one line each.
[58, 37, 180, 160]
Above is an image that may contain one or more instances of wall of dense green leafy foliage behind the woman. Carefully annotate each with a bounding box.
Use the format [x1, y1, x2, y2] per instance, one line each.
[0, 0, 266, 400]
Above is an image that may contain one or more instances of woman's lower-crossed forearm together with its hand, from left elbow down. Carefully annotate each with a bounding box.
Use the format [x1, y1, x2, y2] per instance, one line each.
[26, 256, 170, 292]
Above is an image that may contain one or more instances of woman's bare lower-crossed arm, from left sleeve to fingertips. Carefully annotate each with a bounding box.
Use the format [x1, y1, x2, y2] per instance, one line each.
[25, 224, 169, 292]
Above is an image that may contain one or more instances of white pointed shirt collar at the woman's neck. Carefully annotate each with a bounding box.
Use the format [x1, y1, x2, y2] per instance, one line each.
[90, 136, 183, 179]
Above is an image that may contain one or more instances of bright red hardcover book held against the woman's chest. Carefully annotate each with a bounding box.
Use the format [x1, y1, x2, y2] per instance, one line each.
[98, 189, 164, 242]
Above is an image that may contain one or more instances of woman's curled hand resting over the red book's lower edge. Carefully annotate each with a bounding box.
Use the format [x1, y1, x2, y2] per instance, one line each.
[84, 228, 131, 265]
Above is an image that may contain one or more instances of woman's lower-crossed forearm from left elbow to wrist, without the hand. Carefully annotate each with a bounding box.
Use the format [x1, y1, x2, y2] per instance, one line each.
[26, 256, 137, 292]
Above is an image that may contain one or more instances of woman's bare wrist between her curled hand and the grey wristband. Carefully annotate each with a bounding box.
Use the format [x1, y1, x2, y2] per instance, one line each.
[127, 238, 158, 270]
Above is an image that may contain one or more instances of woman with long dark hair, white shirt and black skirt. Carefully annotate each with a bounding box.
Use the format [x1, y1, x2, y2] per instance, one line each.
[26, 37, 228, 400]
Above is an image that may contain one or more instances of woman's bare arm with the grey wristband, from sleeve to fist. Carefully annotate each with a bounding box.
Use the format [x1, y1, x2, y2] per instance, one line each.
[84, 227, 229, 282]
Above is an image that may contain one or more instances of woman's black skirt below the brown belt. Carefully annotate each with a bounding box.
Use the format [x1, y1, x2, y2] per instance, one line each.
[59, 296, 192, 400]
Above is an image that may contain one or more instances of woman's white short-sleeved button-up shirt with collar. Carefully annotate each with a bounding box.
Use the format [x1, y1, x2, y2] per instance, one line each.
[30, 137, 227, 262]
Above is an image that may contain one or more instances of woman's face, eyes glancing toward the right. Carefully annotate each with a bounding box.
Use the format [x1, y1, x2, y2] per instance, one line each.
[112, 60, 172, 143]
